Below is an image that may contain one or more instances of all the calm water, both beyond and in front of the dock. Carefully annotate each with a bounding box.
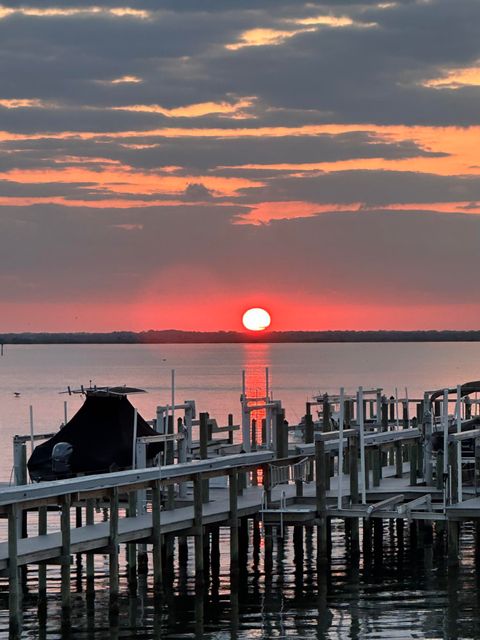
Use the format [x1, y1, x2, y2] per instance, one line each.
[0, 343, 480, 640]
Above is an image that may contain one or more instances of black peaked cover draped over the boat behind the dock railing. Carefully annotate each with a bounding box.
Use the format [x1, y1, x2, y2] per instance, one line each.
[27, 394, 163, 482]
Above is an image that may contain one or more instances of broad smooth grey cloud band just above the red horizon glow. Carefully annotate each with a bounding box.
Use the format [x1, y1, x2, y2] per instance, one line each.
[0, 207, 480, 304]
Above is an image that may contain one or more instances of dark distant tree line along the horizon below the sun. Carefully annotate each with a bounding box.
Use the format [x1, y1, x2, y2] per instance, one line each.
[0, 329, 480, 344]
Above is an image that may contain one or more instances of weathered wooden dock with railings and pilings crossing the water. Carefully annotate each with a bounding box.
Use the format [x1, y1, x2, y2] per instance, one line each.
[0, 382, 480, 637]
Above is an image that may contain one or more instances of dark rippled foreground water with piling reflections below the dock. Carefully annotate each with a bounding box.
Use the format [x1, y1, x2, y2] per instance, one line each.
[8, 521, 480, 640]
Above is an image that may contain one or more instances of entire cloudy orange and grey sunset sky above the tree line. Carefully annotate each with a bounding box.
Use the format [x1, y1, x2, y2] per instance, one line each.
[0, 0, 480, 332]
